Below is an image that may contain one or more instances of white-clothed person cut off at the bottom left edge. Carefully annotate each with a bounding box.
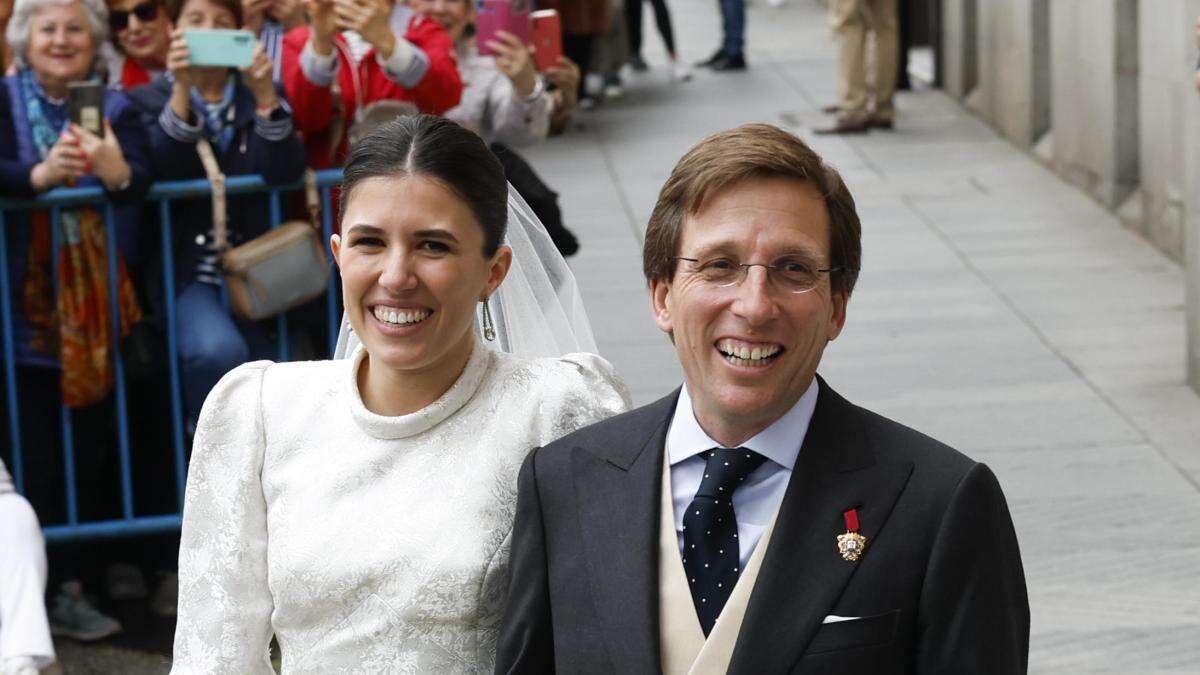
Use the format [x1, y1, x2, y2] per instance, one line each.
[0, 460, 54, 675]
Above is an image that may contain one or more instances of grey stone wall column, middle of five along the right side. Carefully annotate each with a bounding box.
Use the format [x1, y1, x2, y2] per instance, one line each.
[1050, 0, 1139, 209]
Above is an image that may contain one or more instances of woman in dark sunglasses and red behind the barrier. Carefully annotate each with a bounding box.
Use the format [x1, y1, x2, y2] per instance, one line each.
[104, 0, 170, 91]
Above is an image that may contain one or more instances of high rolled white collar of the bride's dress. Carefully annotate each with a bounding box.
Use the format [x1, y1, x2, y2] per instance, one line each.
[346, 342, 492, 441]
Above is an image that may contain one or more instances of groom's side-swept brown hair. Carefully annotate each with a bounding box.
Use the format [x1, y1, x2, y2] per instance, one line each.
[642, 124, 863, 295]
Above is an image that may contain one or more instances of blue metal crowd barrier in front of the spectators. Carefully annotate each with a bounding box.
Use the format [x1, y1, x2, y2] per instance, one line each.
[0, 169, 342, 542]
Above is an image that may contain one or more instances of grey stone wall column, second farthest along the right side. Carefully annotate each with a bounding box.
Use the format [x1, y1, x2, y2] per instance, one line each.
[967, 0, 1050, 147]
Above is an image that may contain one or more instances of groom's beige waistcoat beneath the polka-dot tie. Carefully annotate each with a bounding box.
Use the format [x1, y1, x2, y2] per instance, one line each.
[659, 453, 779, 675]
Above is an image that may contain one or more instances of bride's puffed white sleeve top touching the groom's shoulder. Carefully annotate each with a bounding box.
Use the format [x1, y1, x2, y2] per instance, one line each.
[538, 352, 631, 446]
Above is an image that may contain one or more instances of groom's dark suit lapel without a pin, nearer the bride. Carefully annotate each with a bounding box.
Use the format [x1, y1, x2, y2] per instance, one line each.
[571, 390, 678, 673]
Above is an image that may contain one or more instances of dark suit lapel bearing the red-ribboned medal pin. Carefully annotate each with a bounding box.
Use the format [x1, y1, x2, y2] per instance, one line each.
[728, 381, 912, 674]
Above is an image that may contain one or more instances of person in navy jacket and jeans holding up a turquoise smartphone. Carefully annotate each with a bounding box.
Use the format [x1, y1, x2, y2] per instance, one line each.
[130, 0, 305, 423]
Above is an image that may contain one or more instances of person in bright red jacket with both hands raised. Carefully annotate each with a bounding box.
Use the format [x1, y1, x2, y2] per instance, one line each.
[283, 0, 462, 168]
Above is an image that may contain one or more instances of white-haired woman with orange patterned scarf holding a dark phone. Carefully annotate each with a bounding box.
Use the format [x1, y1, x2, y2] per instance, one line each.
[0, 0, 151, 640]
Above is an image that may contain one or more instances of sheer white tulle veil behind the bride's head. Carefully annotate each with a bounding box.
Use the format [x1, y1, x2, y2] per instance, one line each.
[334, 185, 598, 359]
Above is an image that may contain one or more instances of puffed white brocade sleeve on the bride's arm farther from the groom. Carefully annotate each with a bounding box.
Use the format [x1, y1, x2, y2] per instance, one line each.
[172, 362, 275, 674]
